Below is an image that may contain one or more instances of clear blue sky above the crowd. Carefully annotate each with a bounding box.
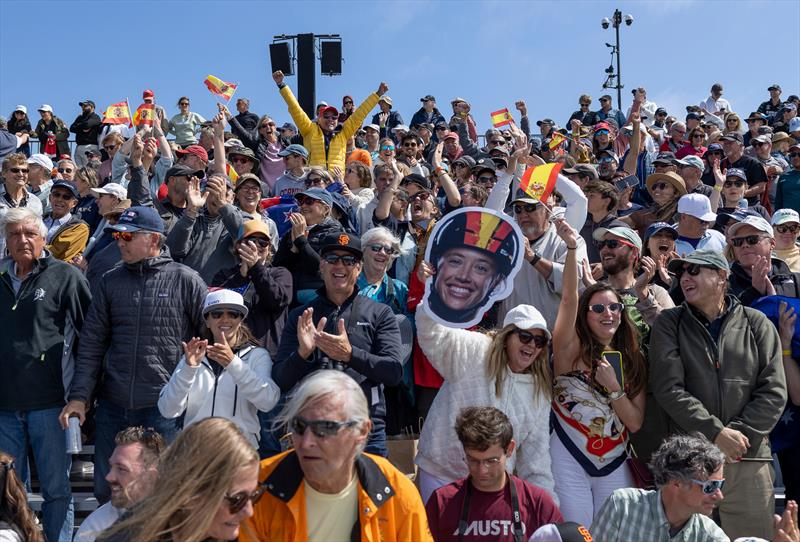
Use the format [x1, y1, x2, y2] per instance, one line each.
[0, 0, 800, 134]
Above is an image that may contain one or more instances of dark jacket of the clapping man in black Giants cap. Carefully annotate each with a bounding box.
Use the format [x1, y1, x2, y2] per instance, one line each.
[272, 288, 403, 425]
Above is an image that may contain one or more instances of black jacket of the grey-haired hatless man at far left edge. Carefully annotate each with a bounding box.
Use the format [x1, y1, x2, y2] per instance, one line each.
[0, 255, 91, 410]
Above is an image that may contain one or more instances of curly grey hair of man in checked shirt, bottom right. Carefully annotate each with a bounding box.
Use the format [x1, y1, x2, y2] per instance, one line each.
[650, 433, 725, 487]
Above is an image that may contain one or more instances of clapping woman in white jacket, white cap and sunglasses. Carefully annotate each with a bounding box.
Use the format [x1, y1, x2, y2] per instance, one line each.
[158, 290, 280, 447]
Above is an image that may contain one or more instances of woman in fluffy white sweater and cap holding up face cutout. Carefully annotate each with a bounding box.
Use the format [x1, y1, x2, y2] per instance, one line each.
[415, 262, 558, 503]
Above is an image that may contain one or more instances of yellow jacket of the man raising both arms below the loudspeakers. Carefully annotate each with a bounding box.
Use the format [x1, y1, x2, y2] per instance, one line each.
[281, 85, 379, 175]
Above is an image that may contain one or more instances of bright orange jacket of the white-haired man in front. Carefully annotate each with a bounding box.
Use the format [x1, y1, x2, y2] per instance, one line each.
[239, 450, 433, 542]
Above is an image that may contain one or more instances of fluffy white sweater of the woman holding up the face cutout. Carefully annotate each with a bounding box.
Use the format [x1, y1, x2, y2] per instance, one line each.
[415, 305, 558, 503]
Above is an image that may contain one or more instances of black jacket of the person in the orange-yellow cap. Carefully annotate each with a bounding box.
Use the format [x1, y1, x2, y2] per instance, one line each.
[211, 263, 292, 358]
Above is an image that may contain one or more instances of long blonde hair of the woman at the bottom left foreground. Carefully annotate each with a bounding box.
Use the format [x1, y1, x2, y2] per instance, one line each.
[101, 418, 258, 542]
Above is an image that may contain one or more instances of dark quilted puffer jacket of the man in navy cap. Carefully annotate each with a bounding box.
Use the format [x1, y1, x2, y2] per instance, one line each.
[69, 250, 206, 409]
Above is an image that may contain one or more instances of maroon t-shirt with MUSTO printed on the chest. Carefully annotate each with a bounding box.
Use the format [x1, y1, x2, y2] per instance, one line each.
[425, 476, 564, 542]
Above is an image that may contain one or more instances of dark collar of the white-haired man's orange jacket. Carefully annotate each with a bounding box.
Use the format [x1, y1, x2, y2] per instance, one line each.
[263, 451, 395, 509]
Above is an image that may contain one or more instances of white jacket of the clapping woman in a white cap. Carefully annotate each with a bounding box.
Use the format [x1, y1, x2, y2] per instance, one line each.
[158, 347, 280, 447]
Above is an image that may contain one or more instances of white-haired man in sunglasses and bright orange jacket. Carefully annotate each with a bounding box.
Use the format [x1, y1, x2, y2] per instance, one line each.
[240, 372, 433, 542]
